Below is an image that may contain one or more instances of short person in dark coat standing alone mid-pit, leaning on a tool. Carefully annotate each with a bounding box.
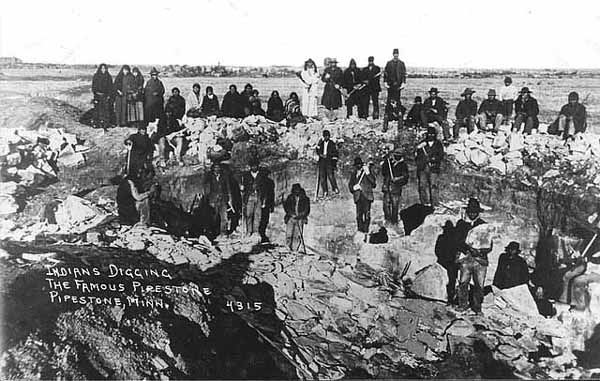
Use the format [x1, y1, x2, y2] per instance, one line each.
[283, 183, 310, 251]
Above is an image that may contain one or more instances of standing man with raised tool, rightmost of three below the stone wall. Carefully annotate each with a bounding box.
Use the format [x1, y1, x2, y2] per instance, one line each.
[415, 127, 444, 206]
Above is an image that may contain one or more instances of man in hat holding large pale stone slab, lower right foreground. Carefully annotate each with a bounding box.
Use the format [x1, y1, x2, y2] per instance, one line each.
[456, 198, 492, 313]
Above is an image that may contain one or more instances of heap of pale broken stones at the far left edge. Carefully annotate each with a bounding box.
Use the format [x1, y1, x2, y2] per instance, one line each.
[0, 124, 88, 215]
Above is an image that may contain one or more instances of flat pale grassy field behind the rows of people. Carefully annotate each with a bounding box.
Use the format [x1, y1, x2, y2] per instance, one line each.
[0, 69, 600, 132]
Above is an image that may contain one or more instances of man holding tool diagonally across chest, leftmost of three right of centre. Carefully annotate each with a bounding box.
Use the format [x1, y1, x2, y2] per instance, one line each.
[348, 157, 377, 233]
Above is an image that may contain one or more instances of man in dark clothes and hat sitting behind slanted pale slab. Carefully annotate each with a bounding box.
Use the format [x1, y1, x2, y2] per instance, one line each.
[493, 241, 529, 289]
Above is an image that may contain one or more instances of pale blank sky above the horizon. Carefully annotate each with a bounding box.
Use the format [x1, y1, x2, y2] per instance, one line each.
[0, 0, 600, 68]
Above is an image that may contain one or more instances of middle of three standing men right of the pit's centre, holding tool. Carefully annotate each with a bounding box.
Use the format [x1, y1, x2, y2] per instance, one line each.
[381, 143, 409, 226]
